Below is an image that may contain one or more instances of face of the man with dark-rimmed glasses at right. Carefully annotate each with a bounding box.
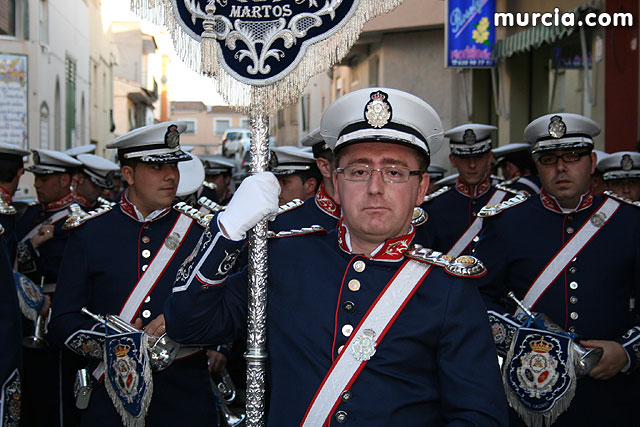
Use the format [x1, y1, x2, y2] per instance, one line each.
[536, 150, 596, 208]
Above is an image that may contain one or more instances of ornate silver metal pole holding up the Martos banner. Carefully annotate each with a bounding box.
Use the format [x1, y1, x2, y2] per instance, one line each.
[244, 109, 269, 426]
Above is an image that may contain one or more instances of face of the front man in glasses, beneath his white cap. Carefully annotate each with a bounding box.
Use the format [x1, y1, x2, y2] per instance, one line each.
[333, 142, 429, 244]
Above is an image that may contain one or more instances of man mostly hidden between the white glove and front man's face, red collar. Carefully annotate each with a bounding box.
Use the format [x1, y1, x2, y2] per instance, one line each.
[269, 128, 340, 232]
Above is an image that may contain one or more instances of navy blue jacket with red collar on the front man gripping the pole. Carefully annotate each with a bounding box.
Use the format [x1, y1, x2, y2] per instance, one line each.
[165, 222, 506, 426]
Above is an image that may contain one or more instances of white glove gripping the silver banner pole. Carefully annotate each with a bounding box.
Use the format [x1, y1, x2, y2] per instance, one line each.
[218, 172, 280, 241]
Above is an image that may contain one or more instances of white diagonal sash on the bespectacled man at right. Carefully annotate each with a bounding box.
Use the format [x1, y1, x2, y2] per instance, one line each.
[516, 198, 620, 314]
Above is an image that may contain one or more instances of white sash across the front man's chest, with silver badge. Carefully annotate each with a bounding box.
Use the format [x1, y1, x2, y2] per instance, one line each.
[300, 260, 431, 427]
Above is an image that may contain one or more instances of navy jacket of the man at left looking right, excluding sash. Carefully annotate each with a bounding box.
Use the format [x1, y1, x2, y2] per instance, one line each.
[49, 202, 216, 426]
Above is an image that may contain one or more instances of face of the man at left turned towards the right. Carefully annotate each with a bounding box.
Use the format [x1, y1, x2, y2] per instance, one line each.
[122, 163, 180, 213]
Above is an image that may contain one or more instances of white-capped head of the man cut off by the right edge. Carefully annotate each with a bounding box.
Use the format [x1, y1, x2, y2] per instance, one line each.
[598, 151, 640, 202]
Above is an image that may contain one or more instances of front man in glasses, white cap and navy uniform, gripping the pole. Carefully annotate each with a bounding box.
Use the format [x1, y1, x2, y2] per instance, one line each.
[165, 88, 506, 426]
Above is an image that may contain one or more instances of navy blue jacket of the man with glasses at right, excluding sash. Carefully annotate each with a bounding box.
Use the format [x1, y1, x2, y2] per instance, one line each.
[475, 192, 640, 426]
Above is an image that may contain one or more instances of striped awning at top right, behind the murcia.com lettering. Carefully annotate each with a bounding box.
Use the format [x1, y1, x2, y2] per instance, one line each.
[493, 1, 602, 60]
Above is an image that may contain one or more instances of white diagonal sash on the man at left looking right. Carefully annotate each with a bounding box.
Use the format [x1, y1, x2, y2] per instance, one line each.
[93, 214, 194, 380]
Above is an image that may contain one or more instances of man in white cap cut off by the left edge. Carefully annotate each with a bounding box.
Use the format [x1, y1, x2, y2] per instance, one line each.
[0, 142, 31, 262]
